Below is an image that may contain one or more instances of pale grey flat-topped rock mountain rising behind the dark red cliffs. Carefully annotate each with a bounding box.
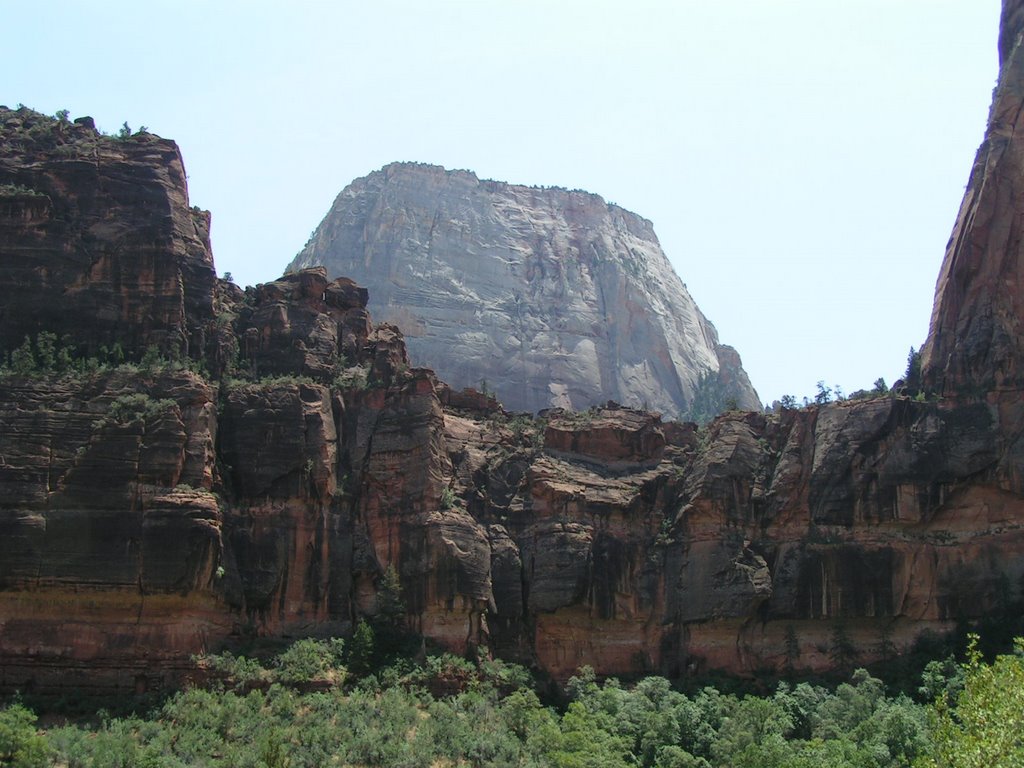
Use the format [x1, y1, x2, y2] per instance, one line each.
[289, 163, 760, 417]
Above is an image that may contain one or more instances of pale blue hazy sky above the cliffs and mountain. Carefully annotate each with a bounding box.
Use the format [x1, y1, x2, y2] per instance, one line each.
[6, 0, 999, 402]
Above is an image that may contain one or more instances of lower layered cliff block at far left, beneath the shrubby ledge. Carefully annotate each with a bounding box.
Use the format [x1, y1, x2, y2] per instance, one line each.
[0, 372, 232, 691]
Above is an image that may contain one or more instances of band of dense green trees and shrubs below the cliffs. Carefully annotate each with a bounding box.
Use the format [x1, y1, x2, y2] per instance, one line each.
[0, 638, 1024, 768]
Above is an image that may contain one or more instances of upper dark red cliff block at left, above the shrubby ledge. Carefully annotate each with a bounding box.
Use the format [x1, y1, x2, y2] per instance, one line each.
[0, 108, 216, 359]
